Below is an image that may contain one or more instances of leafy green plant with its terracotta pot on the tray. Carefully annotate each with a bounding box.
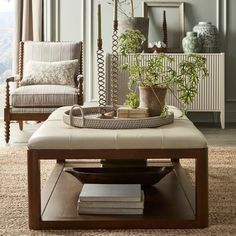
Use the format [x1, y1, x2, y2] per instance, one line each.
[119, 29, 208, 116]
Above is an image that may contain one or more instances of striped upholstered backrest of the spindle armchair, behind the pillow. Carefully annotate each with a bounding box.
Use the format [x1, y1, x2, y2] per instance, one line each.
[23, 41, 82, 84]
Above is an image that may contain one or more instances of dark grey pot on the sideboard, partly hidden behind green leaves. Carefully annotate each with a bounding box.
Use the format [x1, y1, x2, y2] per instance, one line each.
[119, 17, 149, 52]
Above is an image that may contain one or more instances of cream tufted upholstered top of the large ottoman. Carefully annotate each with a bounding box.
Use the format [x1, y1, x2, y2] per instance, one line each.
[28, 107, 207, 149]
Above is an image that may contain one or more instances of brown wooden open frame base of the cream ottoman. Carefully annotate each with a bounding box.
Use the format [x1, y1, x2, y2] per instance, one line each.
[28, 148, 208, 229]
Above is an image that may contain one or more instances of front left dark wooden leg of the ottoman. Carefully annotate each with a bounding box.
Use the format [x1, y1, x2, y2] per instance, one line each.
[27, 150, 41, 229]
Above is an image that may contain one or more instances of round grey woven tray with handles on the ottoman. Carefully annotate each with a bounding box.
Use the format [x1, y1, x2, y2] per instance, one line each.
[63, 105, 174, 129]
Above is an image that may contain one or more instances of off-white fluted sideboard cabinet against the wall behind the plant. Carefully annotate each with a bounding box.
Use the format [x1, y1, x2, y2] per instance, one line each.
[106, 53, 225, 129]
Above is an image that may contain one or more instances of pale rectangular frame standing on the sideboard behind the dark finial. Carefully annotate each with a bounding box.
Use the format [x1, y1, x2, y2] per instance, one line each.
[143, 0, 184, 52]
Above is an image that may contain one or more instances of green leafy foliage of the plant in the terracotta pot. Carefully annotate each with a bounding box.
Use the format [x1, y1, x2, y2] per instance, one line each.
[119, 29, 208, 113]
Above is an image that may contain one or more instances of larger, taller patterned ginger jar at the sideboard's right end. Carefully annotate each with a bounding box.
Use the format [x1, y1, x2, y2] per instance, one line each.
[193, 22, 218, 53]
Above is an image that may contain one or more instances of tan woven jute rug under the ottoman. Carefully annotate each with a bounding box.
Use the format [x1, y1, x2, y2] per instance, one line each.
[0, 147, 236, 236]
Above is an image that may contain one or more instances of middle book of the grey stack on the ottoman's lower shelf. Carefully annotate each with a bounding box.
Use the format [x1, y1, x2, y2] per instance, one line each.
[78, 191, 144, 210]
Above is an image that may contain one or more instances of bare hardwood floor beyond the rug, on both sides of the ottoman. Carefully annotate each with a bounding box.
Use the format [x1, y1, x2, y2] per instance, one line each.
[0, 121, 236, 147]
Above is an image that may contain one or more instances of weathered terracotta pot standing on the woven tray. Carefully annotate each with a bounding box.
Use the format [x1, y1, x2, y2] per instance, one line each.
[139, 86, 167, 116]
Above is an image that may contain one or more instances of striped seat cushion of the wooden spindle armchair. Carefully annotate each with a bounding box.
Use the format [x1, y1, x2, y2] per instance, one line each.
[11, 85, 78, 107]
